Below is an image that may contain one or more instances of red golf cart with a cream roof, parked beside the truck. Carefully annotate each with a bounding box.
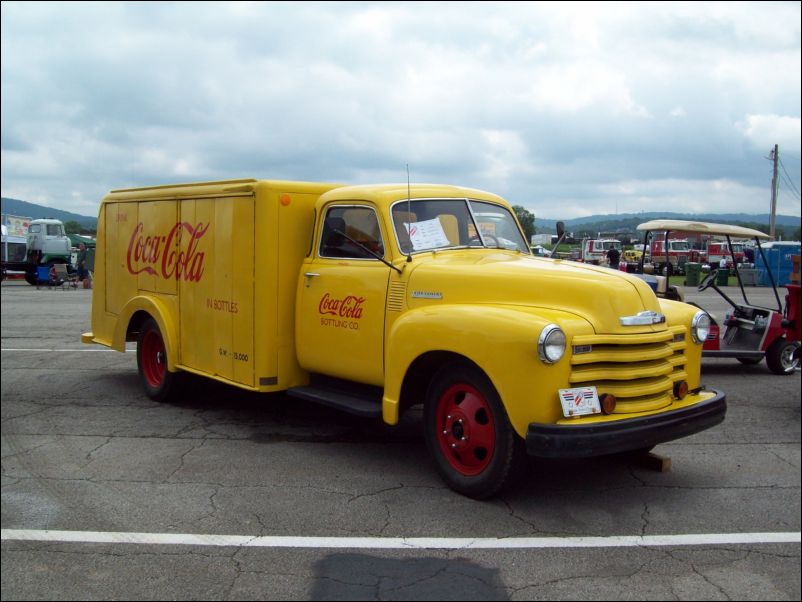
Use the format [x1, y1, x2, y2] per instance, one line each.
[638, 220, 802, 374]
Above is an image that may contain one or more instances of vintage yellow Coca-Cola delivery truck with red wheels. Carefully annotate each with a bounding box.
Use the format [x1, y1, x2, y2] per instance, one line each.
[83, 180, 726, 498]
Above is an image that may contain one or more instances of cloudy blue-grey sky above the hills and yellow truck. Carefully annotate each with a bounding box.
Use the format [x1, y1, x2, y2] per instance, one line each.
[1, 1, 802, 219]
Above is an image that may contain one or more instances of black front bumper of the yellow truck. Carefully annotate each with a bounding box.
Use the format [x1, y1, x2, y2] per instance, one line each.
[526, 389, 727, 458]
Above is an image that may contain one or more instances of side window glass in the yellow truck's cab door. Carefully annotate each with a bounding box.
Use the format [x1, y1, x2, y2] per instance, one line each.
[318, 206, 384, 260]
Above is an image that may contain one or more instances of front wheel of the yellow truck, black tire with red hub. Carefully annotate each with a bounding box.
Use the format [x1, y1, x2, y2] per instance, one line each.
[424, 362, 526, 499]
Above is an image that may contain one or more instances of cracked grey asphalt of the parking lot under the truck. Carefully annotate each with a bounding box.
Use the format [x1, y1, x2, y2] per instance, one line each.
[1, 281, 800, 600]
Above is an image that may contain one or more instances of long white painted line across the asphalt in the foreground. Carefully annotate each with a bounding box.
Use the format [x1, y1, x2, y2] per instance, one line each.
[2, 529, 802, 550]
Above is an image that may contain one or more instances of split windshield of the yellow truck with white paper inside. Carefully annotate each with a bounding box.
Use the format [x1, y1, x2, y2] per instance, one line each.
[392, 199, 530, 254]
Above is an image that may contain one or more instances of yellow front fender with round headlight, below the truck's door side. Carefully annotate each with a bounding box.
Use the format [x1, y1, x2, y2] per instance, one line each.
[382, 305, 593, 437]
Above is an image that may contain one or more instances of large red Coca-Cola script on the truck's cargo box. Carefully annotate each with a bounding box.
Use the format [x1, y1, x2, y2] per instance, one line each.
[127, 222, 209, 282]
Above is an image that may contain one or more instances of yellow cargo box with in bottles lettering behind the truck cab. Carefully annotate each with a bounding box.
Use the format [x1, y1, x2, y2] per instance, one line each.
[84, 179, 336, 391]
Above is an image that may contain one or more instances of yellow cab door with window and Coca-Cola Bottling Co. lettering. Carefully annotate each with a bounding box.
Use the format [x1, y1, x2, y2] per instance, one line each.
[295, 205, 390, 385]
